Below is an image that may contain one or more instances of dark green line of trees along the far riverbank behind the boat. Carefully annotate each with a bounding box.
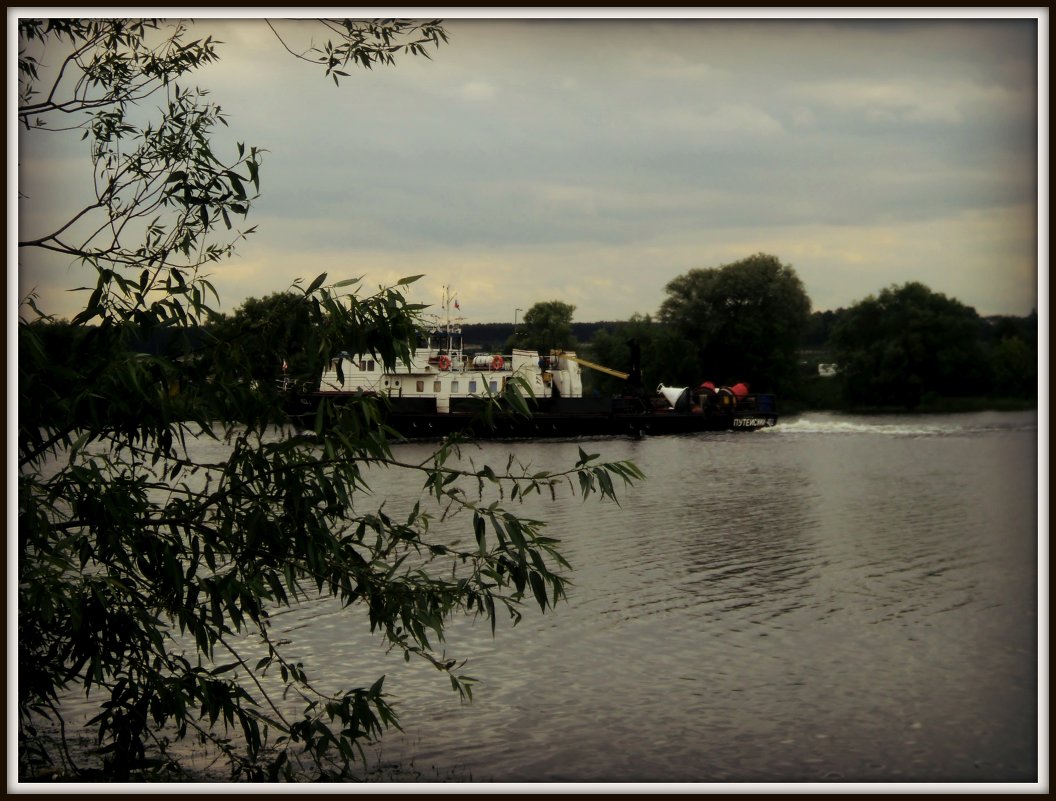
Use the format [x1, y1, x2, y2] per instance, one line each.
[28, 253, 1038, 409]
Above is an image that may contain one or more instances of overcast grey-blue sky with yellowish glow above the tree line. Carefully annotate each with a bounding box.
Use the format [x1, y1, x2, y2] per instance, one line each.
[8, 8, 1048, 323]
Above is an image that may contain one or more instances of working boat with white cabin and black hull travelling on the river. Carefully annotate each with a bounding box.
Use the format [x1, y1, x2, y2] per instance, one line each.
[283, 289, 777, 439]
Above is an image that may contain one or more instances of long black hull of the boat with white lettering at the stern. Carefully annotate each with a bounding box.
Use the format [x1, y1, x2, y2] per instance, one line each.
[290, 394, 777, 439]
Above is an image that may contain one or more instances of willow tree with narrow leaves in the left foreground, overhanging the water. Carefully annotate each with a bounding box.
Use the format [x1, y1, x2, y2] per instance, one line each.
[13, 19, 640, 780]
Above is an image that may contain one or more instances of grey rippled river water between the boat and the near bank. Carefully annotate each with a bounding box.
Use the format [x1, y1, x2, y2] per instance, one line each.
[268, 414, 1048, 783]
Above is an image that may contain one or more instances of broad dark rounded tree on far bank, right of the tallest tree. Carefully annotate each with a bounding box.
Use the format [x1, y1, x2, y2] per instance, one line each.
[830, 282, 991, 408]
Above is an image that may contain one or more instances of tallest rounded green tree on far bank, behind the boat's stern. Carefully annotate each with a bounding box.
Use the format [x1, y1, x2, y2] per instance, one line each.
[658, 253, 810, 392]
